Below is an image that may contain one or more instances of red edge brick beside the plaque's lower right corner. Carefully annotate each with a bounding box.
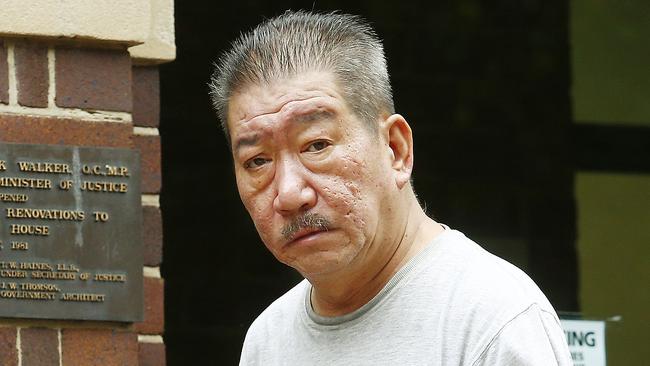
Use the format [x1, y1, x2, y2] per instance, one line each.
[135, 277, 165, 334]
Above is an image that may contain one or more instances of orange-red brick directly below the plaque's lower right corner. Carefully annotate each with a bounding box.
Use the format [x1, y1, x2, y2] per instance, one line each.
[62, 329, 138, 366]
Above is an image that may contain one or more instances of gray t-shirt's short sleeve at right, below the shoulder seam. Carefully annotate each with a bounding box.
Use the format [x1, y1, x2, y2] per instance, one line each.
[472, 304, 573, 366]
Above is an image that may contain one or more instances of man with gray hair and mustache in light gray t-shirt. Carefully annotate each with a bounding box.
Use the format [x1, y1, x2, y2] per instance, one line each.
[211, 12, 570, 365]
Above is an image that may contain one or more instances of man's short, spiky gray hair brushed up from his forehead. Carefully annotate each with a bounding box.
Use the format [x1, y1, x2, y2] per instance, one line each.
[209, 11, 395, 138]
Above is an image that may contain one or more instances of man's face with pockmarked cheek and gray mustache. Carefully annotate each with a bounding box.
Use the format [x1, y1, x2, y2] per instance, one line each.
[228, 72, 394, 277]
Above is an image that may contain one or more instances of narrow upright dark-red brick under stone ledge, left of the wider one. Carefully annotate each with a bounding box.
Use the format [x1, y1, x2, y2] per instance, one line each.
[14, 43, 50, 108]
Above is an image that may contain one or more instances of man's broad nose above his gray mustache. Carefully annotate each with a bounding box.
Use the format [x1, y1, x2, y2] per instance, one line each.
[273, 157, 317, 216]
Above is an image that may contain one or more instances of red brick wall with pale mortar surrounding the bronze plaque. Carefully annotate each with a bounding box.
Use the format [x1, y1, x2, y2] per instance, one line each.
[0, 39, 165, 366]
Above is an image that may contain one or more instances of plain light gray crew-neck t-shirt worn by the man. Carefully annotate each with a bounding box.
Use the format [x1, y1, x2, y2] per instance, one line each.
[240, 229, 572, 366]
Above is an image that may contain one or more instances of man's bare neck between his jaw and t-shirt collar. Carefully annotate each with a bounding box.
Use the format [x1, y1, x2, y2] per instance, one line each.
[309, 195, 444, 316]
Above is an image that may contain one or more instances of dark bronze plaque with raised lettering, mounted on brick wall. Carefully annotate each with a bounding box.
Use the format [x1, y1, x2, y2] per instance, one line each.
[0, 143, 143, 322]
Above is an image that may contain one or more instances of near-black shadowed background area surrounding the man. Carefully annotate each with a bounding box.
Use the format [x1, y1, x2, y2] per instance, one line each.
[160, 0, 578, 365]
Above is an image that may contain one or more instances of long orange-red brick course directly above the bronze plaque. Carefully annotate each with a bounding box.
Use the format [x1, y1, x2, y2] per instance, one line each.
[0, 114, 133, 148]
